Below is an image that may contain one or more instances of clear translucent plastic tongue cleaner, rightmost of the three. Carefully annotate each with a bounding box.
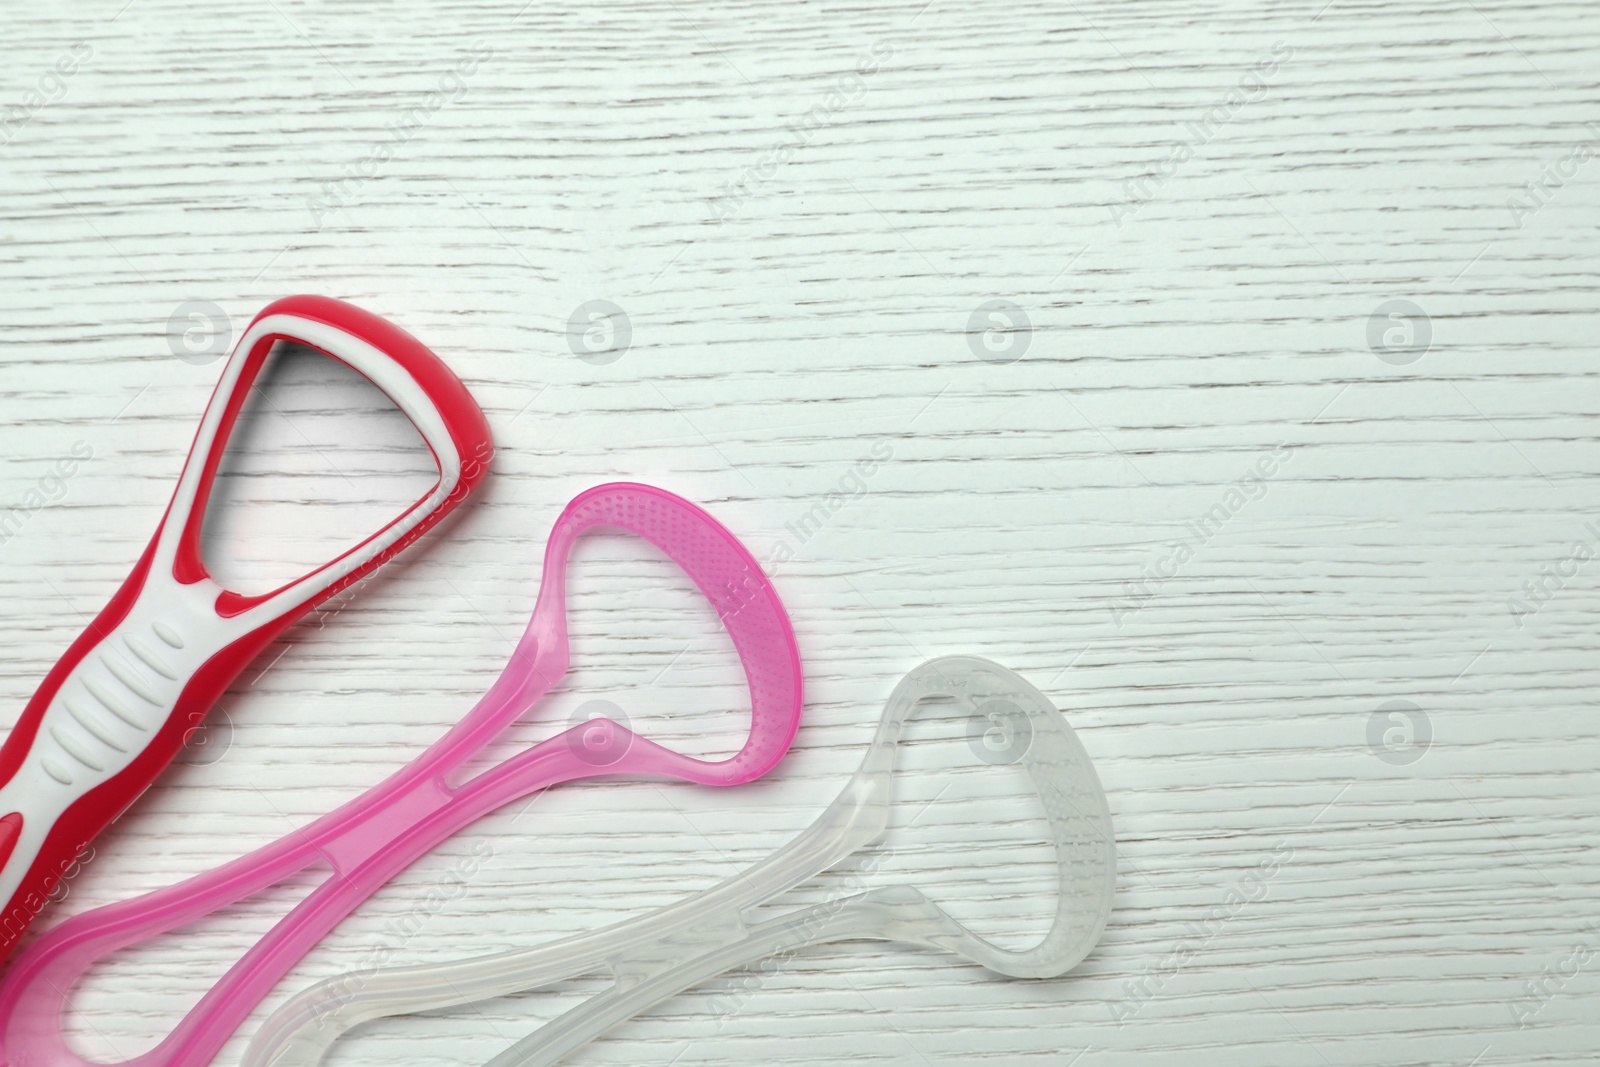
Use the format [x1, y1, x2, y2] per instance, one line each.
[243, 656, 1117, 1067]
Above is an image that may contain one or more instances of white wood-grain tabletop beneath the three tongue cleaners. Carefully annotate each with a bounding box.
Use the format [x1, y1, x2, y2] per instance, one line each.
[0, 0, 1600, 1067]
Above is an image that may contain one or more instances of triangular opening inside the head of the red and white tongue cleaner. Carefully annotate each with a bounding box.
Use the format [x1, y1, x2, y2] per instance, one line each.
[200, 341, 438, 595]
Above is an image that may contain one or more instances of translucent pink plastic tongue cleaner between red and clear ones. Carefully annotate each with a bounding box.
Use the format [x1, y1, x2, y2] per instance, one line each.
[0, 483, 803, 1067]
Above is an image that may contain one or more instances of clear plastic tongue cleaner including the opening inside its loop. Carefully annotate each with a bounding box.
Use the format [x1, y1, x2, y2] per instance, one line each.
[243, 656, 1115, 1067]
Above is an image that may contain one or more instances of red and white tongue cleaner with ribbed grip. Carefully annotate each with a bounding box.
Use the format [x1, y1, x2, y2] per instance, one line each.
[0, 296, 493, 960]
